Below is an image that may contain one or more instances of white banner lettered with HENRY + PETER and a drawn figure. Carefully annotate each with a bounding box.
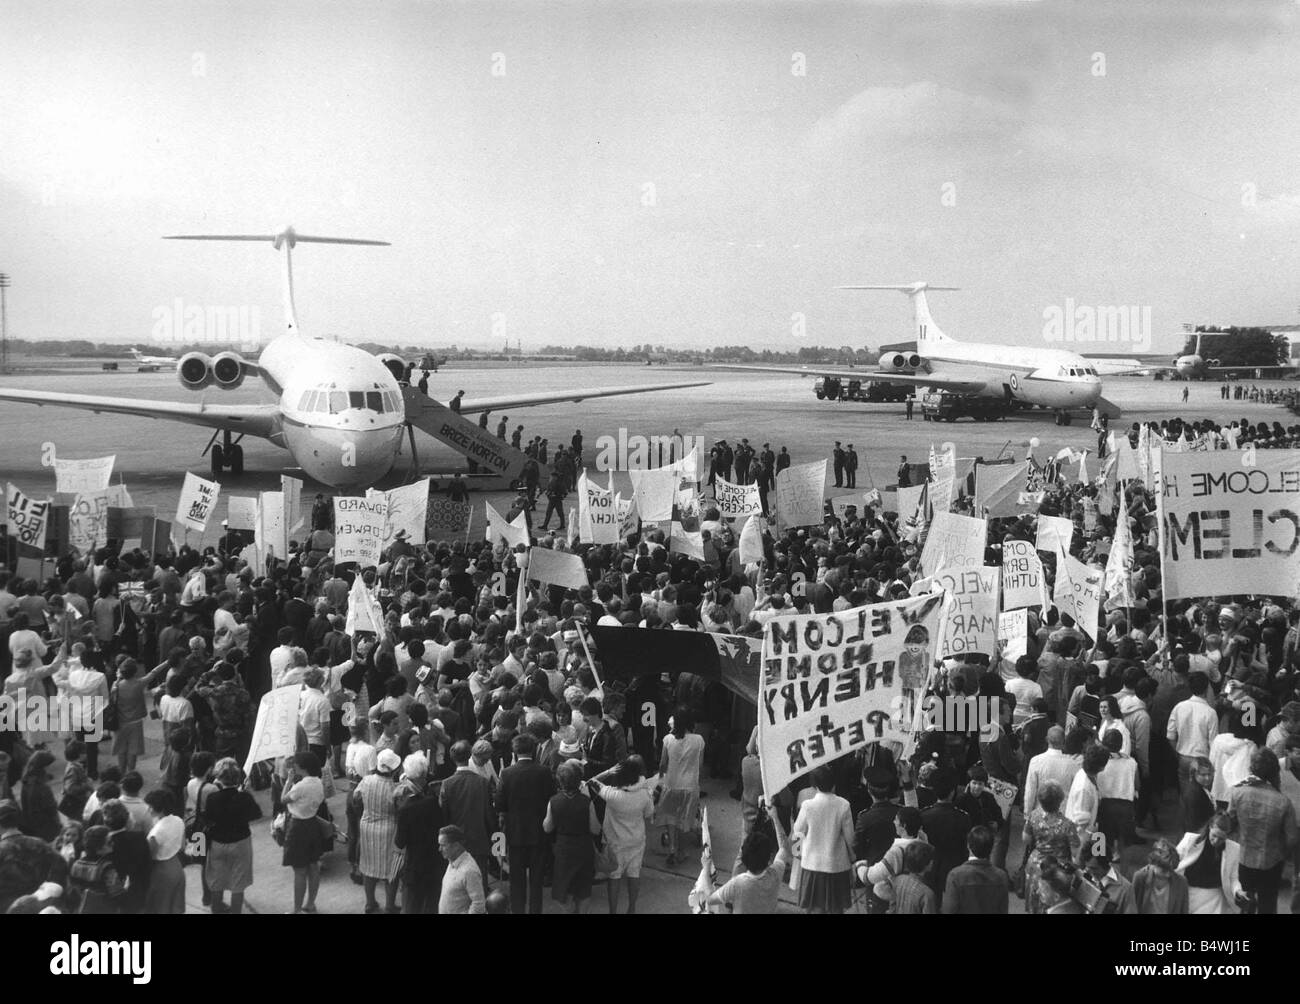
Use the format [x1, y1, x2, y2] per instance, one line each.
[754, 593, 944, 799]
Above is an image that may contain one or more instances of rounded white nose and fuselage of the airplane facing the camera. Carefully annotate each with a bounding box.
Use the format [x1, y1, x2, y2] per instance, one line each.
[250, 334, 404, 490]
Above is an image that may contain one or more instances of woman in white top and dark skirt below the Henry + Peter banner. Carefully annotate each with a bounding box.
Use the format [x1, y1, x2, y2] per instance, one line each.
[790, 766, 853, 913]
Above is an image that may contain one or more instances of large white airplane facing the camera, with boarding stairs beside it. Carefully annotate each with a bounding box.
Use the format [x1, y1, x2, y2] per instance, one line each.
[0, 226, 706, 492]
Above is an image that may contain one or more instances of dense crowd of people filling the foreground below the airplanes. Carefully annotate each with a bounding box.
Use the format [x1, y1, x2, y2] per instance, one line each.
[0, 410, 1300, 913]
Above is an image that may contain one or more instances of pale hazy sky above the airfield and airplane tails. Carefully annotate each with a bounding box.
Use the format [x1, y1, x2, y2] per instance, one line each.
[0, 0, 1300, 352]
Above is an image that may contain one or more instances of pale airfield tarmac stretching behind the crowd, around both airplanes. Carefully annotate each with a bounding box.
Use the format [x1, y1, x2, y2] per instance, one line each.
[0, 364, 1294, 544]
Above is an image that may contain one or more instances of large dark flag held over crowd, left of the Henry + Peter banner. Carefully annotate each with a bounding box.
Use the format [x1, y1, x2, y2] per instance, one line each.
[589, 624, 763, 705]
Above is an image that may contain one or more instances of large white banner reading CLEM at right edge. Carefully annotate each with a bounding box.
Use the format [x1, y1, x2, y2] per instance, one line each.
[1157, 449, 1300, 600]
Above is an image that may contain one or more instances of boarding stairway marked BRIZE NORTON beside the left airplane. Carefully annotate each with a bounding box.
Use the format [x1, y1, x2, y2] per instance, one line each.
[402, 385, 551, 492]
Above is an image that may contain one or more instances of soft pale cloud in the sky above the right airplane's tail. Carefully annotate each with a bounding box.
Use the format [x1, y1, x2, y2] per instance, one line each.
[806, 81, 1021, 157]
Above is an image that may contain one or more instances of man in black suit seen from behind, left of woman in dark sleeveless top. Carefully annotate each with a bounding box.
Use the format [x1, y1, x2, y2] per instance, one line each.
[497, 732, 555, 913]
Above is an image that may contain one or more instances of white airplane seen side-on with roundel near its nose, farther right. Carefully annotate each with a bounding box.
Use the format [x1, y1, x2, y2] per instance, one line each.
[725, 282, 1119, 425]
